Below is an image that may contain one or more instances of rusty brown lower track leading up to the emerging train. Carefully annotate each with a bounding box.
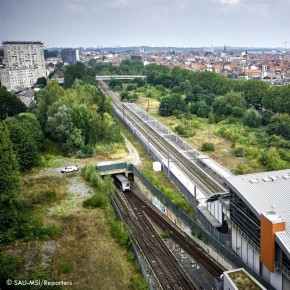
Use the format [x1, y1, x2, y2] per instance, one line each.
[113, 189, 200, 290]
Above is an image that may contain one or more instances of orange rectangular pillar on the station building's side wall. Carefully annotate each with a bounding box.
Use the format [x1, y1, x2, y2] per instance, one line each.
[260, 211, 285, 272]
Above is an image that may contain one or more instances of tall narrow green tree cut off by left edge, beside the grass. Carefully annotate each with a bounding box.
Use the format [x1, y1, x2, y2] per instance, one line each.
[0, 123, 19, 242]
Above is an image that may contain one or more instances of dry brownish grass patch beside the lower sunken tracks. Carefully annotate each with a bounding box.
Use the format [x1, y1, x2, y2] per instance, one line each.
[52, 208, 147, 290]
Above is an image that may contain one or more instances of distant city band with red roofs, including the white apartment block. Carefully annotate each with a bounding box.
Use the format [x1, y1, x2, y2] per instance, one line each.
[0, 41, 290, 90]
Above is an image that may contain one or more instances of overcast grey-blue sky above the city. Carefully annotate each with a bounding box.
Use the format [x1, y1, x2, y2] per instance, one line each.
[0, 0, 290, 48]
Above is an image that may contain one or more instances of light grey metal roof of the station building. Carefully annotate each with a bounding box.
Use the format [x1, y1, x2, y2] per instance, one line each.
[225, 169, 290, 258]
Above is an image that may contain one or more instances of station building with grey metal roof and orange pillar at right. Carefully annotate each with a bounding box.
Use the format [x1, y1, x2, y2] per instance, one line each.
[225, 170, 290, 290]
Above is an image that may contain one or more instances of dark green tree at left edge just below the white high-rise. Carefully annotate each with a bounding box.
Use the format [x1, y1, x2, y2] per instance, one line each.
[0, 87, 27, 120]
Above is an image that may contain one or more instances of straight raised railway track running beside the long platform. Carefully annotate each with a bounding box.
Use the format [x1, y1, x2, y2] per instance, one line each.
[100, 81, 226, 196]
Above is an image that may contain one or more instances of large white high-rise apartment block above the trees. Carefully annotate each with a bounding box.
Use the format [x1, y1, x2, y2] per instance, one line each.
[0, 41, 46, 90]
